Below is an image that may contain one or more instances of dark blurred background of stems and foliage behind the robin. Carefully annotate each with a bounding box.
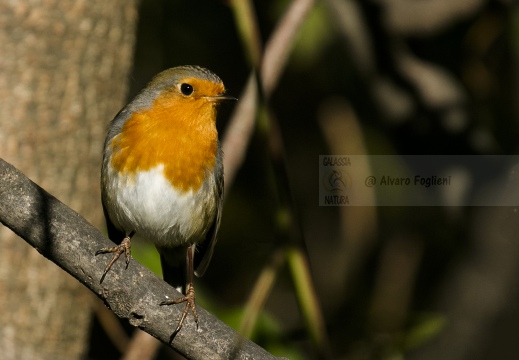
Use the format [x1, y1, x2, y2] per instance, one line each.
[0, 0, 519, 360]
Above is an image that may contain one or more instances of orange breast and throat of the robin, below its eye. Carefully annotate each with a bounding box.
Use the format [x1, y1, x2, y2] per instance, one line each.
[111, 92, 218, 192]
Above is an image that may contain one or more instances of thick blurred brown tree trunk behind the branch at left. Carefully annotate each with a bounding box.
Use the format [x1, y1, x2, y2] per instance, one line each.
[0, 0, 136, 359]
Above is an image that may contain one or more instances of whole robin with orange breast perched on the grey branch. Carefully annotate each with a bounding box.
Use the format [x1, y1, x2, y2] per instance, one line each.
[96, 66, 236, 336]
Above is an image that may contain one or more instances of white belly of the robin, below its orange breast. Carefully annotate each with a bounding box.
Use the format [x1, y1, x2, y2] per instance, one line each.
[104, 165, 216, 246]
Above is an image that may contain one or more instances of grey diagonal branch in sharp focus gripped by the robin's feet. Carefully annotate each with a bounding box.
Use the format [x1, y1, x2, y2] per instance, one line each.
[0, 159, 275, 359]
